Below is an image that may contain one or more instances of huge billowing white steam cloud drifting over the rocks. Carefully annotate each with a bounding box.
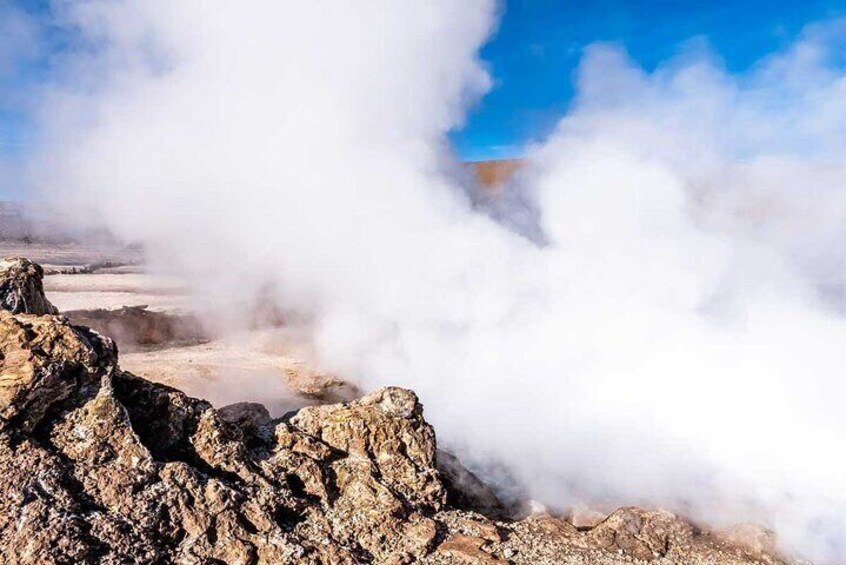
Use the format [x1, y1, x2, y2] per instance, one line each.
[21, 0, 846, 560]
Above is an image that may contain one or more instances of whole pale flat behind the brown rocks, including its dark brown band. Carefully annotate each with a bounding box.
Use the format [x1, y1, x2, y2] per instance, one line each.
[0, 223, 354, 415]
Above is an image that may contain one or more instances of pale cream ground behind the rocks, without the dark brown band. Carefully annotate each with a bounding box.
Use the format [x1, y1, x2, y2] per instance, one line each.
[0, 241, 354, 415]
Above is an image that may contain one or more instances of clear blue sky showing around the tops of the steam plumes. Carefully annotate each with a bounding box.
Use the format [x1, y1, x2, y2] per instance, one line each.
[0, 0, 846, 160]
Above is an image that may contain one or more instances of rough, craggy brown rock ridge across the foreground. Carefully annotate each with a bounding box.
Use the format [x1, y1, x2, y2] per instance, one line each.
[0, 258, 796, 565]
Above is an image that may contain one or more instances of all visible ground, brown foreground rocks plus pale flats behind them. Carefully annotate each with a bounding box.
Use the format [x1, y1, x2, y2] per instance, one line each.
[0, 217, 788, 565]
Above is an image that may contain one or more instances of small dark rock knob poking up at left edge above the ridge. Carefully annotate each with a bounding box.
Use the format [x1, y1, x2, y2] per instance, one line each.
[0, 257, 59, 316]
